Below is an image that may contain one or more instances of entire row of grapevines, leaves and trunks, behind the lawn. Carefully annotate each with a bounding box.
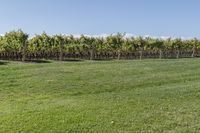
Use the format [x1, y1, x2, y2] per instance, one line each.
[0, 30, 200, 61]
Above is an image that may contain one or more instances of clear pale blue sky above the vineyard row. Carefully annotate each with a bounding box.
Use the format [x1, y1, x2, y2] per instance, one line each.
[0, 0, 200, 38]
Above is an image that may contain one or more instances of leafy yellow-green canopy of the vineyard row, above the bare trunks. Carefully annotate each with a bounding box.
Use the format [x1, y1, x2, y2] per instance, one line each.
[0, 30, 200, 58]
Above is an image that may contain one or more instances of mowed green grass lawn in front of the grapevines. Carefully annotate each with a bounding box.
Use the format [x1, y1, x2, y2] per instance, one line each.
[0, 59, 200, 133]
